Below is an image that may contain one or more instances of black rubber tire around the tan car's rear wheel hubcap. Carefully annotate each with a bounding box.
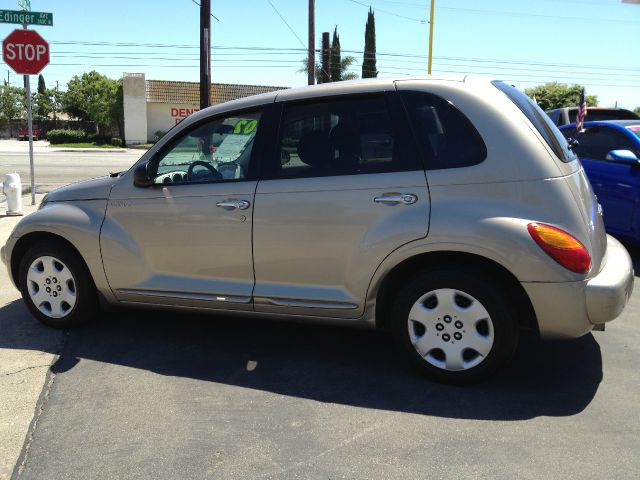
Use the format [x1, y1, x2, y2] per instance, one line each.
[391, 265, 519, 385]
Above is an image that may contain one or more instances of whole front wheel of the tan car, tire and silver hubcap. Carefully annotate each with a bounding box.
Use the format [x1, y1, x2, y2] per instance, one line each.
[19, 241, 98, 328]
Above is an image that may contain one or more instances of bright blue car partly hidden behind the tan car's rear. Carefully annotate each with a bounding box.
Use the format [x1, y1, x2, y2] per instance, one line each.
[560, 120, 640, 243]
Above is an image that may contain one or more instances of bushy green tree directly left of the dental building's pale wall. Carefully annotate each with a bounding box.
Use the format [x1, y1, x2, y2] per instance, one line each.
[62, 70, 119, 133]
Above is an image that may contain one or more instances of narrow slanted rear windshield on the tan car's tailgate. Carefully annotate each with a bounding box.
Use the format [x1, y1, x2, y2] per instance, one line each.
[493, 82, 576, 163]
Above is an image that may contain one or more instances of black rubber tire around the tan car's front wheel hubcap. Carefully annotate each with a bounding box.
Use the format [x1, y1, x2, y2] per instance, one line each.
[19, 240, 99, 328]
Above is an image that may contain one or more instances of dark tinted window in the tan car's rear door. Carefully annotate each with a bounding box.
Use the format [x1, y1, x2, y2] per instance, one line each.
[265, 96, 421, 178]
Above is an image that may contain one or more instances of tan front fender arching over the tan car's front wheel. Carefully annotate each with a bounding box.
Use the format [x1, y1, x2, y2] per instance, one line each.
[4, 200, 111, 297]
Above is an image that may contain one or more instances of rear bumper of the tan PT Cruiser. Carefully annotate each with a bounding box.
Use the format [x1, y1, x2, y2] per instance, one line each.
[522, 235, 634, 338]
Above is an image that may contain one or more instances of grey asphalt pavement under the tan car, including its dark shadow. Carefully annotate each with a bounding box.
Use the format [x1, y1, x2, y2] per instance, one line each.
[0, 202, 640, 479]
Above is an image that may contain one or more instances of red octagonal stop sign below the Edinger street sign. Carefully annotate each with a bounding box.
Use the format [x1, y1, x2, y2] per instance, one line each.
[2, 30, 49, 75]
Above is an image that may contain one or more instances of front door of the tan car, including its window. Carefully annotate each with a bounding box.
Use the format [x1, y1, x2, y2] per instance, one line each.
[100, 110, 261, 310]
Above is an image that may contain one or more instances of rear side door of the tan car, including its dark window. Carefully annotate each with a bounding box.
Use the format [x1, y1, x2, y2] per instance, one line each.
[253, 93, 430, 318]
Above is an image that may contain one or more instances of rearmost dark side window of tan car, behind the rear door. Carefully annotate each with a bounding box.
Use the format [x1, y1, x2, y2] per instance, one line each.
[401, 92, 487, 170]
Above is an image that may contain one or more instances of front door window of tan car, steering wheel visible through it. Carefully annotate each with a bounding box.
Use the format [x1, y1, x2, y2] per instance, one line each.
[154, 113, 260, 184]
